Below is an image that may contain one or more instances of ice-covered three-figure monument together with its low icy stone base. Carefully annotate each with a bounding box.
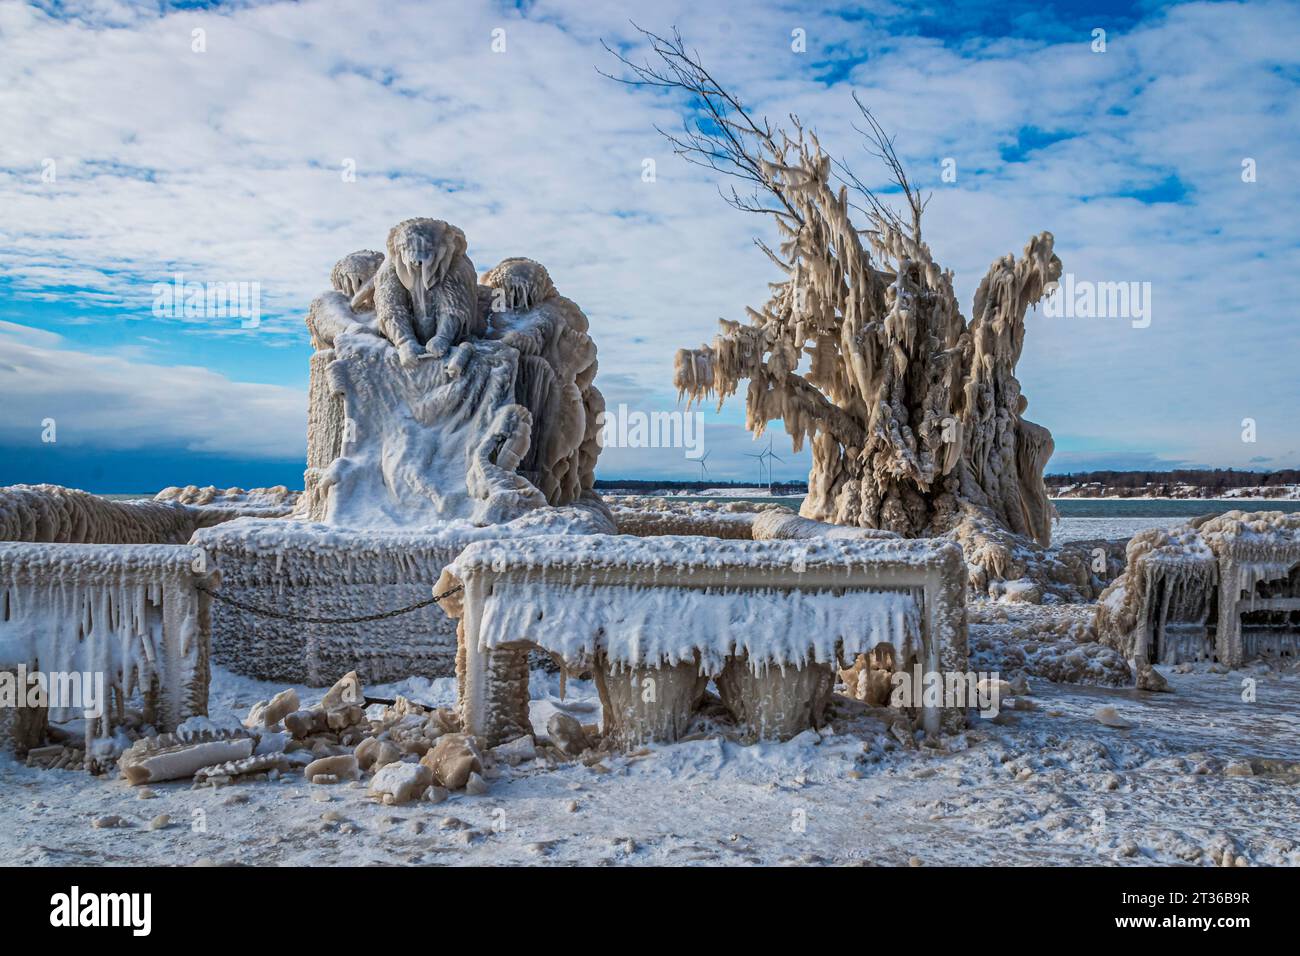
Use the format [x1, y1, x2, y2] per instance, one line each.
[192, 219, 614, 685]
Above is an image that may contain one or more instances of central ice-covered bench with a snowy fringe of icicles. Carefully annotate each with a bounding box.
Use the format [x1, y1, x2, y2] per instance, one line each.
[437, 535, 966, 743]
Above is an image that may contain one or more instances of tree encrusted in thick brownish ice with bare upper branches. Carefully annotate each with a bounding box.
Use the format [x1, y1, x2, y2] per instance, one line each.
[606, 27, 1061, 545]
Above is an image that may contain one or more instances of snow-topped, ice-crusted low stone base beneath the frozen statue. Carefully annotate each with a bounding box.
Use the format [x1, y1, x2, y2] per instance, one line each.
[191, 503, 611, 687]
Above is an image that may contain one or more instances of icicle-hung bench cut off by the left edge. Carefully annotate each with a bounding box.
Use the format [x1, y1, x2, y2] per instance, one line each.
[0, 542, 216, 736]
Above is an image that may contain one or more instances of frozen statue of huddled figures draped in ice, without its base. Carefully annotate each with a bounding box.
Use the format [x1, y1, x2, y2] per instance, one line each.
[304, 219, 605, 528]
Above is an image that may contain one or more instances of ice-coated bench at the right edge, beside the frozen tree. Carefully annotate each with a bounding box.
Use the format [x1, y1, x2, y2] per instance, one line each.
[1097, 511, 1300, 667]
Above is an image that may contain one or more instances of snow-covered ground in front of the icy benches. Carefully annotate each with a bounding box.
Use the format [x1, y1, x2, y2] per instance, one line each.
[0, 655, 1300, 865]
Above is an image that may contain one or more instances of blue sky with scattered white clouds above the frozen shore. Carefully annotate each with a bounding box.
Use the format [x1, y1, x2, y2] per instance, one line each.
[0, 0, 1300, 492]
